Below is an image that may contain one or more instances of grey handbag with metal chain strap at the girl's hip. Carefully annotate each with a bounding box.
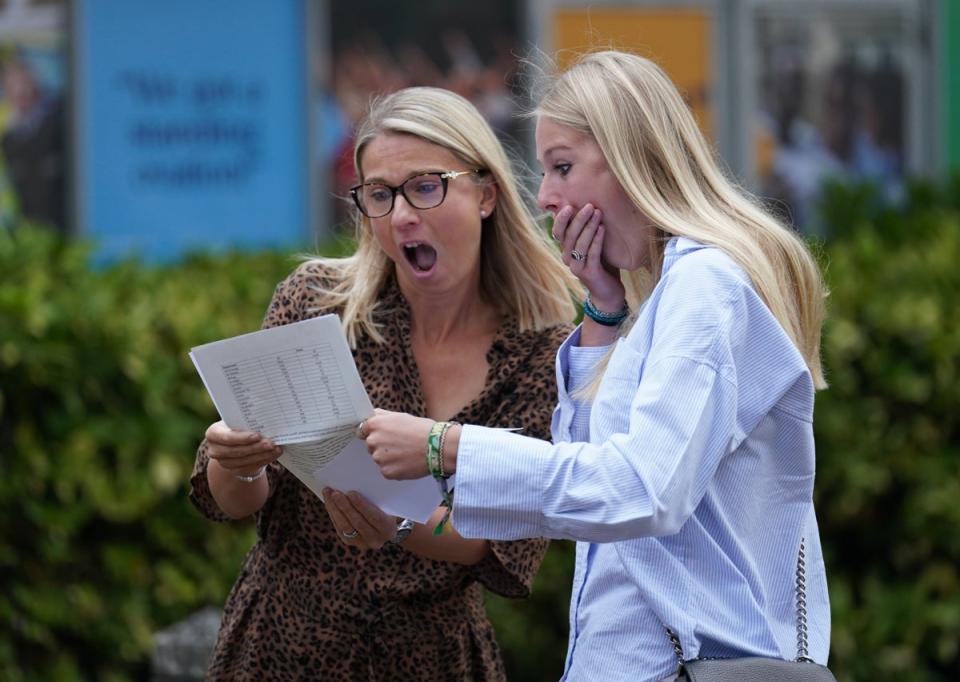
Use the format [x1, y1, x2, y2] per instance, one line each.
[667, 539, 837, 682]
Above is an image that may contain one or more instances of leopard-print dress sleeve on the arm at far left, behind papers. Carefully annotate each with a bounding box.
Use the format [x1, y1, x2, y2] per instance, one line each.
[190, 265, 310, 522]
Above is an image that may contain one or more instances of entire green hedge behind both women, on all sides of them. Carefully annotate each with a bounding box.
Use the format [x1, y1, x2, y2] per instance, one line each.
[0, 181, 960, 682]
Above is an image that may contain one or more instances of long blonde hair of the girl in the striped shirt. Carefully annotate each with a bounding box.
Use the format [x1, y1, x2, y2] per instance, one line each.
[534, 51, 826, 388]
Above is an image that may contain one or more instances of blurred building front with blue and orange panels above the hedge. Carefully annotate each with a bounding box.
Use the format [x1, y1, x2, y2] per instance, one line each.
[0, 0, 960, 255]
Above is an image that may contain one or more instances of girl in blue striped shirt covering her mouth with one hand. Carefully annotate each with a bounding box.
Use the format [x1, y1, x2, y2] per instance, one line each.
[362, 52, 830, 682]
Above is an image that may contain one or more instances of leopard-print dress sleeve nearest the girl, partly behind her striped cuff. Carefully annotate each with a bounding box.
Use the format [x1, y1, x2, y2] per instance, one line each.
[464, 327, 569, 599]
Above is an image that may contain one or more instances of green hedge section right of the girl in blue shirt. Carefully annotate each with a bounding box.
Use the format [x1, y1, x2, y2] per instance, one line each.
[814, 176, 960, 682]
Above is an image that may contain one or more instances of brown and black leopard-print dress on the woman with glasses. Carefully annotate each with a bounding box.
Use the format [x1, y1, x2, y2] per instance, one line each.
[190, 262, 570, 682]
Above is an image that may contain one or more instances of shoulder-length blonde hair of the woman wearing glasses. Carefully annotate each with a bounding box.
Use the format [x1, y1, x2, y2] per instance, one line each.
[318, 87, 579, 347]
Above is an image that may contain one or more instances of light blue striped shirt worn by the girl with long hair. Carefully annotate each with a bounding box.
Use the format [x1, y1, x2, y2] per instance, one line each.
[454, 238, 830, 682]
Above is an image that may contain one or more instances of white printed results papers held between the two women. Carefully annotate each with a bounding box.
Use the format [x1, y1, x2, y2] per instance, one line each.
[190, 315, 440, 523]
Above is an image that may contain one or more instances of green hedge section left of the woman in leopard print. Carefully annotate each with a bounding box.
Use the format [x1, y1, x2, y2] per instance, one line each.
[0, 230, 294, 682]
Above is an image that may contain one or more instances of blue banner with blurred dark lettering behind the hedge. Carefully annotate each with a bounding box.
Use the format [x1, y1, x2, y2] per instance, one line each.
[74, 0, 310, 260]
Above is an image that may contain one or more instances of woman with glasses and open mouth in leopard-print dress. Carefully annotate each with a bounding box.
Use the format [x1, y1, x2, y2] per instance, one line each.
[191, 88, 576, 681]
